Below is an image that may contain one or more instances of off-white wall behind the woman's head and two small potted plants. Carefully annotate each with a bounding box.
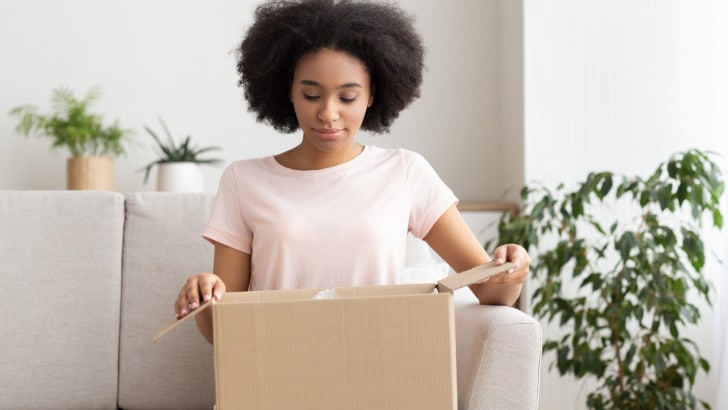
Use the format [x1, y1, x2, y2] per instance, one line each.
[0, 0, 522, 200]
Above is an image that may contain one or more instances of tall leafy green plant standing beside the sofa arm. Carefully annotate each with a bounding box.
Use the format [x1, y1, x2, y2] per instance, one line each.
[486, 149, 724, 409]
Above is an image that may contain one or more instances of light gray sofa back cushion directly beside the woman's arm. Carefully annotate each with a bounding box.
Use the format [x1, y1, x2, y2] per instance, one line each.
[119, 192, 215, 410]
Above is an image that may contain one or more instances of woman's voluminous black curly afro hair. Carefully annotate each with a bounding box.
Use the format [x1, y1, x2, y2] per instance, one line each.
[237, 0, 424, 133]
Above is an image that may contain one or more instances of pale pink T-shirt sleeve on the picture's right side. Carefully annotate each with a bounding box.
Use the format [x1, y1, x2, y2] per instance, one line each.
[403, 150, 458, 239]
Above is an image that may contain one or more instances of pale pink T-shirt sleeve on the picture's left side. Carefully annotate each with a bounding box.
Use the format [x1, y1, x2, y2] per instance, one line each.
[202, 163, 252, 254]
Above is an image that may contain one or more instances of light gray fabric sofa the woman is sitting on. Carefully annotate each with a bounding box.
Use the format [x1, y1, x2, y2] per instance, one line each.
[0, 191, 541, 410]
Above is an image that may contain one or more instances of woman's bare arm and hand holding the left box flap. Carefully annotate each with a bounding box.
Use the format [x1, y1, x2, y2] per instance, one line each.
[175, 244, 250, 343]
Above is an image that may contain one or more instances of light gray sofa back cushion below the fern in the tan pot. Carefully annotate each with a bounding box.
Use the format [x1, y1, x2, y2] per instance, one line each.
[0, 191, 124, 409]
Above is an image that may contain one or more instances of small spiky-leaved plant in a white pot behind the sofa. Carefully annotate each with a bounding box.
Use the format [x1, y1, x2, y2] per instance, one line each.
[143, 118, 222, 192]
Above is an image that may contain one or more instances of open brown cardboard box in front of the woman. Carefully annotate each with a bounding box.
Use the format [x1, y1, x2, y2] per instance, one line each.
[154, 264, 513, 410]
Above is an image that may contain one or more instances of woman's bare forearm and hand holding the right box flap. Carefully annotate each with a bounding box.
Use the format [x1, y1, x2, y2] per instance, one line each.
[424, 205, 530, 306]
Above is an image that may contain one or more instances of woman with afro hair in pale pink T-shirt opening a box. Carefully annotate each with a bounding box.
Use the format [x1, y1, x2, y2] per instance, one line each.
[175, 0, 529, 343]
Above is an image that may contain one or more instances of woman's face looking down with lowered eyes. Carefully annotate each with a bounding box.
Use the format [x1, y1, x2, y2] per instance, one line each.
[290, 48, 372, 153]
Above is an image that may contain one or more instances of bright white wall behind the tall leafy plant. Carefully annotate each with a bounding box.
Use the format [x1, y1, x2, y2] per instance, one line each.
[524, 0, 728, 409]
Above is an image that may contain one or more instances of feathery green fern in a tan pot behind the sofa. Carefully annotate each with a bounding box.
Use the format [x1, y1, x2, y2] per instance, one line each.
[10, 87, 131, 190]
